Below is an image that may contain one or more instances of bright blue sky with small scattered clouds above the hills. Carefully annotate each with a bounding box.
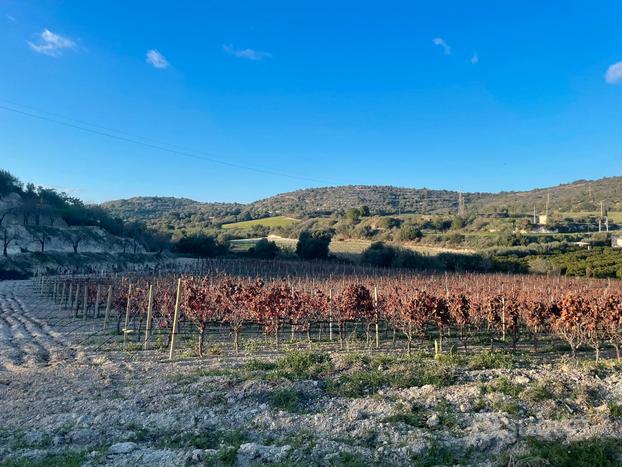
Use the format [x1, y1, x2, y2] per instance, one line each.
[0, 0, 622, 202]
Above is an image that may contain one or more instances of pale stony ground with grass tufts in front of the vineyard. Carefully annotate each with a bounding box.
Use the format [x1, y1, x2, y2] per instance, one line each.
[0, 281, 622, 466]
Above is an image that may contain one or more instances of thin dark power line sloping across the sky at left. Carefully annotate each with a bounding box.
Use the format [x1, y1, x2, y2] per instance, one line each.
[0, 99, 338, 183]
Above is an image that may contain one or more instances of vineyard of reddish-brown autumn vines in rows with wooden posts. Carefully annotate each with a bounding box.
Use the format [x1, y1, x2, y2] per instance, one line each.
[35, 261, 622, 361]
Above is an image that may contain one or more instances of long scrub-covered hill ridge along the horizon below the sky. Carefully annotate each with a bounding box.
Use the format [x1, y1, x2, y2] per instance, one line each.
[101, 177, 622, 230]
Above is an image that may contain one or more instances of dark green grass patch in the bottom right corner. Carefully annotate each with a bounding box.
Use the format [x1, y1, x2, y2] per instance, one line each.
[506, 438, 622, 467]
